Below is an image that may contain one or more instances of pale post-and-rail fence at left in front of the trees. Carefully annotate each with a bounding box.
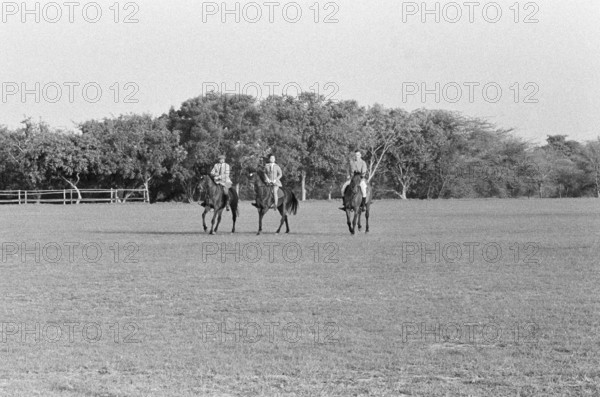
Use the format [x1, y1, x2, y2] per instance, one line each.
[0, 189, 150, 205]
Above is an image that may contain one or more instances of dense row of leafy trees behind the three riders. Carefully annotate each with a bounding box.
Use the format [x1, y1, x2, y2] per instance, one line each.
[0, 93, 600, 202]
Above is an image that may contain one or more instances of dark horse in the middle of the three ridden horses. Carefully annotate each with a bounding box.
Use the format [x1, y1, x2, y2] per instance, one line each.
[250, 170, 298, 235]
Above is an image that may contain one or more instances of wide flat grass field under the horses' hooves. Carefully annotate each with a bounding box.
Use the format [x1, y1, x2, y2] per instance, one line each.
[0, 199, 600, 397]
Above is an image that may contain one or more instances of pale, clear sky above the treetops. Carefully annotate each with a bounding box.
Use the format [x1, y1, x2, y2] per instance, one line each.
[0, 0, 600, 143]
